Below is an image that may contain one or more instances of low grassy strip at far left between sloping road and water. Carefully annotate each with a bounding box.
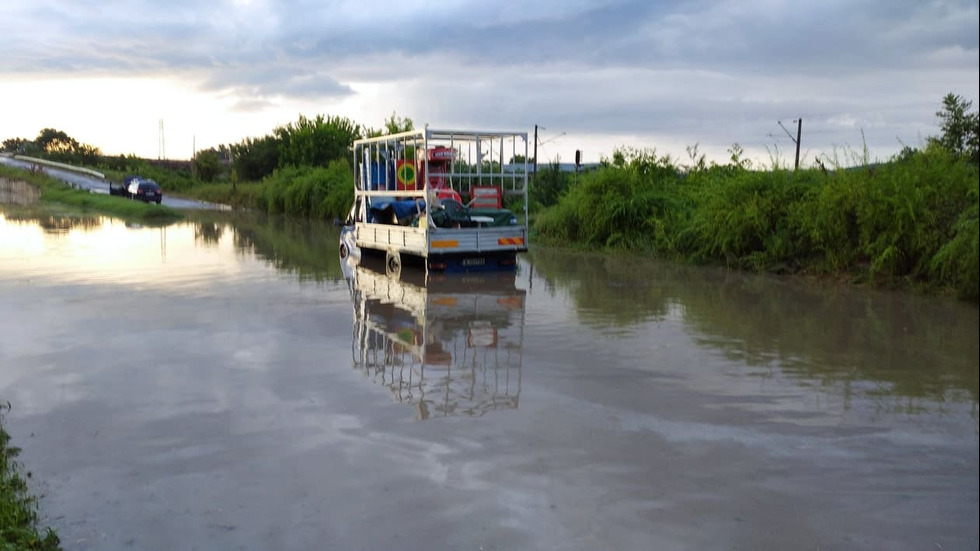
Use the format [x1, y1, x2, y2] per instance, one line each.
[0, 165, 183, 225]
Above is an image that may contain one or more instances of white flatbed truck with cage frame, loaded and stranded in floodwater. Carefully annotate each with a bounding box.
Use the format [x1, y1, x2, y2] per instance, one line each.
[340, 128, 528, 273]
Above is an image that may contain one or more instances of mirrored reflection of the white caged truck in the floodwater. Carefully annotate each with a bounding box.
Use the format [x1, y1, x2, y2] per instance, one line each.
[345, 258, 526, 419]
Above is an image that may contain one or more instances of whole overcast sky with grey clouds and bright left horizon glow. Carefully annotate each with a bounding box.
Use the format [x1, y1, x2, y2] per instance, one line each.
[0, 0, 980, 164]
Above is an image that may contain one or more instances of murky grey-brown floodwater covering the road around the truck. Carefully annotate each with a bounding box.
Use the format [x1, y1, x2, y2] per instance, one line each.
[0, 213, 980, 550]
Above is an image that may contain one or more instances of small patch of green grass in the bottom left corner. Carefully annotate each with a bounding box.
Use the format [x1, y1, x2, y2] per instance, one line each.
[0, 406, 61, 551]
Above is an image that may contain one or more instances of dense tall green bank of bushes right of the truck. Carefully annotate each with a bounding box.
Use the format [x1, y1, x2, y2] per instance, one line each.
[535, 148, 980, 300]
